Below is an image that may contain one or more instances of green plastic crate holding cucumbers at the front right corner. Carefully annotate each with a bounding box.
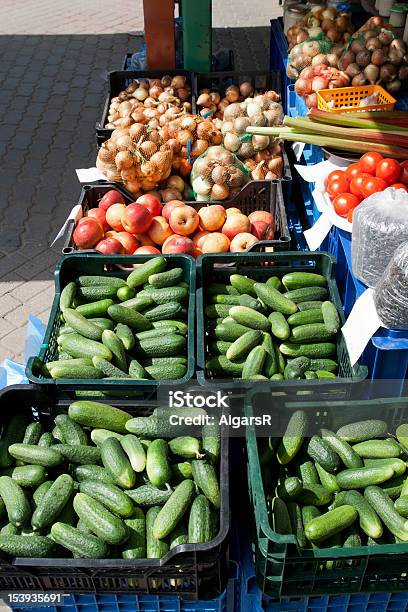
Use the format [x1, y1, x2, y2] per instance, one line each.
[245, 385, 408, 597]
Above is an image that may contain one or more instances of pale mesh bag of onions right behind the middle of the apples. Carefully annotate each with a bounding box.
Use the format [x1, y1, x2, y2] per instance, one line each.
[191, 146, 249, 202]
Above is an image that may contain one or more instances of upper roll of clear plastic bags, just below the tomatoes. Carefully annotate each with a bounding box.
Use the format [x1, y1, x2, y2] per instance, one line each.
[351, 187, 408, 287]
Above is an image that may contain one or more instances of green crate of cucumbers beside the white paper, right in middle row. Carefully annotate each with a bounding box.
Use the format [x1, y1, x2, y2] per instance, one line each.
[197, 251, 367, 390]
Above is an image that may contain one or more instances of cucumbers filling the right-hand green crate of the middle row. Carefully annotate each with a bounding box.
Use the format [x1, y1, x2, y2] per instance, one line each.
[205, 272, 341, 380]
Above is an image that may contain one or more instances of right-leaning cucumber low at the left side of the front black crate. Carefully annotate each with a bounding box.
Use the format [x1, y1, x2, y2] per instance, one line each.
[31, 474, 74, 529]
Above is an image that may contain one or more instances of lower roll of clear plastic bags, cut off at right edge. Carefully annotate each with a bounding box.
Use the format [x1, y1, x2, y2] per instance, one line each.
[374, 241, 408, 329]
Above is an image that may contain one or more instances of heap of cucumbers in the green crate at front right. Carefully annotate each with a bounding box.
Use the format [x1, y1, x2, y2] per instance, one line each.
[260, 410, 408, 548]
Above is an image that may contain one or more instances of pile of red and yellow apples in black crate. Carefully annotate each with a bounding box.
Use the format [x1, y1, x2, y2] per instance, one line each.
[73, 189, 275, 257]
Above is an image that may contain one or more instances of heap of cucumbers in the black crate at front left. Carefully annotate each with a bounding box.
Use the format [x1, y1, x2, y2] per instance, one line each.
[0, 401, 221, 559]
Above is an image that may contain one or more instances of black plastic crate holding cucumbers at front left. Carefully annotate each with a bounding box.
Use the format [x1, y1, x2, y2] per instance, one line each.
[0, 385, 230, 600]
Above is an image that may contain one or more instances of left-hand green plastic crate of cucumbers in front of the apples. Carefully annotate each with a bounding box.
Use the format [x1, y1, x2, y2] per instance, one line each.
[26, 252, 195, 393]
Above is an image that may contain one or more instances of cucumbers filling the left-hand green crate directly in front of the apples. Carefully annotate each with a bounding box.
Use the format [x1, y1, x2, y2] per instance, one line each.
[43, 256, 189, 380]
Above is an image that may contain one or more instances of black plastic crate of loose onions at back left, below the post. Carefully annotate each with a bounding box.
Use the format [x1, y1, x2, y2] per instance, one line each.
[96, 69, 196, 149]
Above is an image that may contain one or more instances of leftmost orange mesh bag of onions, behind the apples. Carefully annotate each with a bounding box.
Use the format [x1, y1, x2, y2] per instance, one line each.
[96, 123, 173, 194]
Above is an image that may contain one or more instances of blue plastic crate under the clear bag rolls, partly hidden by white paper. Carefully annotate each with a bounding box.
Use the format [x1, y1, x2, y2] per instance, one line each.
[332, 230, 408, 388]
